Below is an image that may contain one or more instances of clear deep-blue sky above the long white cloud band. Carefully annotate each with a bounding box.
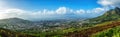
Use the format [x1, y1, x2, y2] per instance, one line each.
[6, 0, 101, 10]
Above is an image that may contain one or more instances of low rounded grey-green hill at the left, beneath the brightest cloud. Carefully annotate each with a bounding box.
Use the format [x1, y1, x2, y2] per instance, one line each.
[0, 18, 33, 30]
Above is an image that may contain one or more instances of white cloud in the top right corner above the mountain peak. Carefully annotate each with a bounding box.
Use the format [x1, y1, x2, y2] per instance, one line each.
[98, 0, 120, 7]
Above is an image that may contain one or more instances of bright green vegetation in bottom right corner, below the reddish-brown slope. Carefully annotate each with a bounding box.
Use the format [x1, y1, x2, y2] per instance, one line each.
[92, 26, 120, 37]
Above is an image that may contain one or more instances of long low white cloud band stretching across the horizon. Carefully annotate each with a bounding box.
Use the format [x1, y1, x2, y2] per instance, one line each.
[0, 7, 104, 20]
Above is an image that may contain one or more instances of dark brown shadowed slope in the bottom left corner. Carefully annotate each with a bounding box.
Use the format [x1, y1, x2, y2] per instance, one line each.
[0, 28, 35, 37]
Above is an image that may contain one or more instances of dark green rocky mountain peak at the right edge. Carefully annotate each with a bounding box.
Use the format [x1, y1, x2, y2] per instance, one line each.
[93, 7, 120, 22]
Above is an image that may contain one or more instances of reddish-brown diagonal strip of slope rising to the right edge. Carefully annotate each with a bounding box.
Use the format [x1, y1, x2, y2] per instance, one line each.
[65, 22, 120, 37]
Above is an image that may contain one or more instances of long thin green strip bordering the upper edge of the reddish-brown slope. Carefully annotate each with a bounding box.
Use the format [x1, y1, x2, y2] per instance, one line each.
[37, 21, 115, 37]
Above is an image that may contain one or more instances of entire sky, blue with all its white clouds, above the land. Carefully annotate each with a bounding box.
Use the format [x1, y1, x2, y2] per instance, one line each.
[0, 0, 120, 20]
